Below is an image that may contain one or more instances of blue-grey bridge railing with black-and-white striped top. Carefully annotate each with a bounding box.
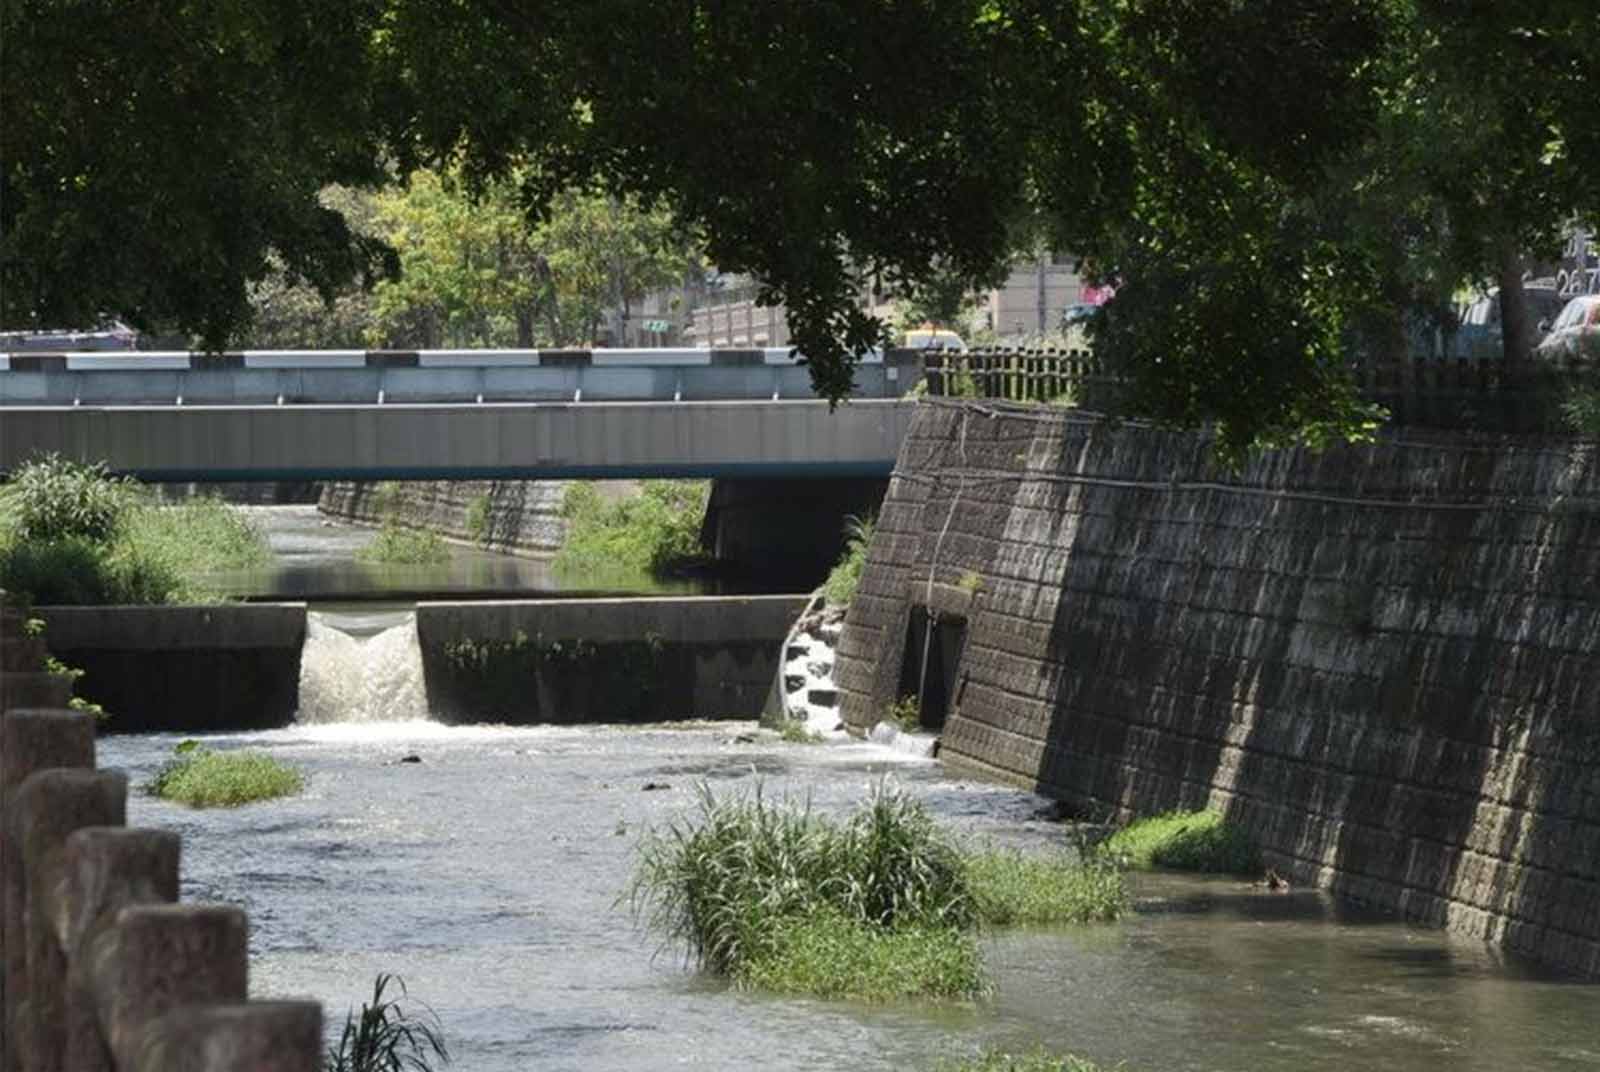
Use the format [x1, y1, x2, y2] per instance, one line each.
[0, 349, 922, 406]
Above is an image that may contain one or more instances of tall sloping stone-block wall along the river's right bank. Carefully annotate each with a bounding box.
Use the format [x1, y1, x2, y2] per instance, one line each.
[837, 403, 1600, 974]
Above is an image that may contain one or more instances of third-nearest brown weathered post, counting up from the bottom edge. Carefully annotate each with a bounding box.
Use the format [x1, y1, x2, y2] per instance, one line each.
[58, 827, 179, 1072]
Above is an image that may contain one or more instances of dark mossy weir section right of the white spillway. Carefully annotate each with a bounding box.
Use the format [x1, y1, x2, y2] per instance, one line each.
[416, 595, 806, 723]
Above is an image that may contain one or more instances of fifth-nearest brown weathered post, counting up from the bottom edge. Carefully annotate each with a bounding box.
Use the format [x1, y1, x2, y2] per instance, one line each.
[0, 710, 94, 1072]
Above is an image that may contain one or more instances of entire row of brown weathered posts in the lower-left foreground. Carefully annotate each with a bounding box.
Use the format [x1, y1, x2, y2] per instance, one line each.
[0, 605, 322, 1072]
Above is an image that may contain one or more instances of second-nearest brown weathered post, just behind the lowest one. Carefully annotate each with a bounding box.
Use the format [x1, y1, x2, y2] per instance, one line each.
[83, 904, 246, 1070]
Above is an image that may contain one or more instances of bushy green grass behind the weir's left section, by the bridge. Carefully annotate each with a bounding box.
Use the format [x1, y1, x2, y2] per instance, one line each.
[0, 454, 270, 605]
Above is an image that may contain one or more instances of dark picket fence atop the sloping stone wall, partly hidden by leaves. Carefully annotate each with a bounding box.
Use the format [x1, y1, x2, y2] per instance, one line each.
[925, 349, 1600, 435]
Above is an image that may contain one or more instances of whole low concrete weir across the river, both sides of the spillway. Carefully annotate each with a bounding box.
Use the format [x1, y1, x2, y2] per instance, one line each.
[35, 595, 805, 733]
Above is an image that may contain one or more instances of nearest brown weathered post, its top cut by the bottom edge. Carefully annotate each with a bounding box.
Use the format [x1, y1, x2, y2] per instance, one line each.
[136, 1002, 322, 1072]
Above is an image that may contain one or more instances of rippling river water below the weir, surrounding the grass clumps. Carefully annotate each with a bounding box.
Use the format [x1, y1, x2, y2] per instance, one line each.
[101, 722, 1600, 1072]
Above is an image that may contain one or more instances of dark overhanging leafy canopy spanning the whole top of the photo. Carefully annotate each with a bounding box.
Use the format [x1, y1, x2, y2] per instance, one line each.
[9, 0, 1600, 450]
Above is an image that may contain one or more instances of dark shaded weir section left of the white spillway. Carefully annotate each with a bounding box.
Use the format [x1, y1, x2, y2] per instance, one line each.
[34, 603, 306, 733]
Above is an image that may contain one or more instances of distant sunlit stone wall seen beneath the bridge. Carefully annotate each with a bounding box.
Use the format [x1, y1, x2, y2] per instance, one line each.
[317, 480, 568, 557]
